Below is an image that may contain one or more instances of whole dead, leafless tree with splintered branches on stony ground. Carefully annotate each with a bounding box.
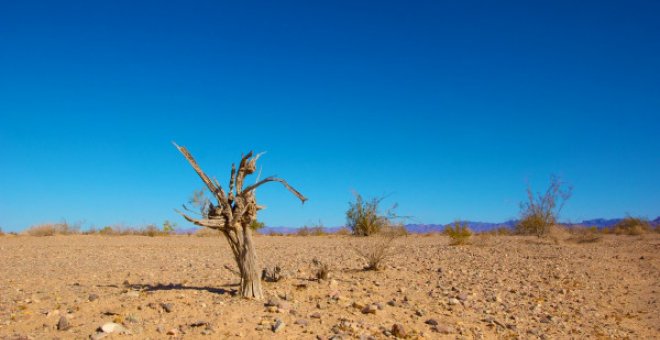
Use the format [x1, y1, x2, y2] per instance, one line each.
[174, 143, 307, 299]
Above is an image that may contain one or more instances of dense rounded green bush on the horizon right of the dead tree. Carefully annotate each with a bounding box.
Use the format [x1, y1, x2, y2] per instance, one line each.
[346, 193, 397, 236]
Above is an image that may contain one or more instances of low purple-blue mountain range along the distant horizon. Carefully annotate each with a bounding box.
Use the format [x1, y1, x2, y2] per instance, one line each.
[177, 217, 660, 234]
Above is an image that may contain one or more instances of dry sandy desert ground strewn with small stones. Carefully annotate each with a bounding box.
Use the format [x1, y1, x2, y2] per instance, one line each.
[0, 235, 660, 339]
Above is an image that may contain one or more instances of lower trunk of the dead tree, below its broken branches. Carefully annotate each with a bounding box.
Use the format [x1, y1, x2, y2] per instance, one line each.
[240, 227, 264, 300]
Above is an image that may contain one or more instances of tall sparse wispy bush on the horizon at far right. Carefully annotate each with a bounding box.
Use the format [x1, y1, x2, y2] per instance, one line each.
[516, 176, 572, 237]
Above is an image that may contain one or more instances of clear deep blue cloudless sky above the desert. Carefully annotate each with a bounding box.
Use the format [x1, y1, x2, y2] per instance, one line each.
[0, 1, 660, 231]
